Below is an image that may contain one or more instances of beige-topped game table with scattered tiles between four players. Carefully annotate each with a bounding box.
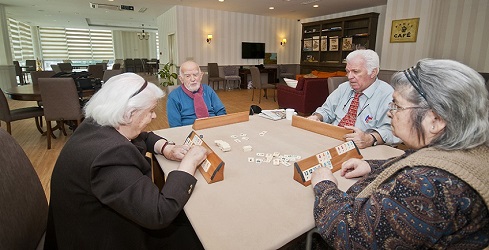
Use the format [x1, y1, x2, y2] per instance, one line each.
[155, 115, 403, 250]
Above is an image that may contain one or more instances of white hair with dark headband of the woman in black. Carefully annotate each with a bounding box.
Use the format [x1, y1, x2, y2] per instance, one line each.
[84, 73, 164, 128]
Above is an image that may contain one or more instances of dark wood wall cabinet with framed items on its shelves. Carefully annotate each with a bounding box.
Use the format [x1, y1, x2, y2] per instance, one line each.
[301, 12, 379, 74]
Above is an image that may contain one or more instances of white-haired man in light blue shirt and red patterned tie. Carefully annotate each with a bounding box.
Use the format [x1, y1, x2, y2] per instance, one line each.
[308, 50, 400, 148]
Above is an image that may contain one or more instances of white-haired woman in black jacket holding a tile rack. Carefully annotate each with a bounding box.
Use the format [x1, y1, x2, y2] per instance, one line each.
[46, 73, 207, 249]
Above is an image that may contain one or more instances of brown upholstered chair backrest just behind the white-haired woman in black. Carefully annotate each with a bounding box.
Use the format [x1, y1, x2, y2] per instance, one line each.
[39, 77, 82, 121]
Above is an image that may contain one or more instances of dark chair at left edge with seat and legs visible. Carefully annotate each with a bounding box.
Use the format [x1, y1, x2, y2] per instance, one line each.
[0, 89, 44, 134]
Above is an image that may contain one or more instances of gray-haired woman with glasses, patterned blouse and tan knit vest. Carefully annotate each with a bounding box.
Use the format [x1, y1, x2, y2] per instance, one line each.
[312, 59, 489, 249]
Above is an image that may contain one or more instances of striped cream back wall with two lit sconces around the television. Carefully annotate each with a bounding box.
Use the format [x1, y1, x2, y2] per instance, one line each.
[157, 6, 301, 66]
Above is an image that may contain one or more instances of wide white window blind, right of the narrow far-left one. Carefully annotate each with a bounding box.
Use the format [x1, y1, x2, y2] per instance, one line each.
[39, 27, 114, 61]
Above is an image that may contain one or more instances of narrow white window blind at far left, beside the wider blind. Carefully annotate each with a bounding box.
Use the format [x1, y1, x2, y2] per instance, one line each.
[7, 18, 35, 62]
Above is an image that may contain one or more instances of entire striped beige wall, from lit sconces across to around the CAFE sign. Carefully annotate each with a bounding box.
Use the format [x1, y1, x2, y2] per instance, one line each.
[158, 0, 489, 72]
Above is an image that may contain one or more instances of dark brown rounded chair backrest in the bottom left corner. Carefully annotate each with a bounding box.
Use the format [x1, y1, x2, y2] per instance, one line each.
[0, 129, 48, 249]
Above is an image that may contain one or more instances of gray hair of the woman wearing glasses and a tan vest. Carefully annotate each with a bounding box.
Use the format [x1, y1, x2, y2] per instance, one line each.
[391, 59, 489, 150]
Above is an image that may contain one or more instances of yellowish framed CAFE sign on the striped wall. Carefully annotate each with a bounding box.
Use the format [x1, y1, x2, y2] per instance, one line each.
[390, 18, 419, 43]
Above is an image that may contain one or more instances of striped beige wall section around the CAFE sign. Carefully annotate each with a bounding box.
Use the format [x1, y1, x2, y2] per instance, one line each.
[381, 0, 489, 72]
